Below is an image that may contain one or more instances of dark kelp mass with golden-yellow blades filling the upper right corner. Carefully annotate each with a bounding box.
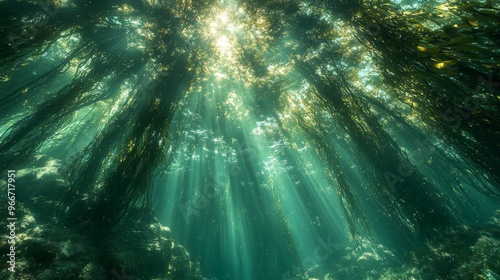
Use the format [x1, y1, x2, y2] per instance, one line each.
[353, 2, 500, 194]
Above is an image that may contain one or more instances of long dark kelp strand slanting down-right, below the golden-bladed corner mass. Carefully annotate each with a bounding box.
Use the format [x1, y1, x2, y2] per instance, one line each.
[296, 55, 453, 240]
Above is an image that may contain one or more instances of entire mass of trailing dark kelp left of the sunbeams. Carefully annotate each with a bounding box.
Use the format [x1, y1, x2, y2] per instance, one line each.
[2, 1, 203, 236]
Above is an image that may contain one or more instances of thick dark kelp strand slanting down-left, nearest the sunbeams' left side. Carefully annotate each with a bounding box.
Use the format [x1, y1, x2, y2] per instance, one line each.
[69, 56, 192, 237]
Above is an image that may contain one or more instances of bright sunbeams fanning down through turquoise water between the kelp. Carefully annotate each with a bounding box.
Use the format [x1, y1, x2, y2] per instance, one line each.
[152, 1, 347, 279]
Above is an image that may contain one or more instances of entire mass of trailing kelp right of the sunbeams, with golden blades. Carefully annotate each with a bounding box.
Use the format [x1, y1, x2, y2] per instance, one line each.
[241, 1, 499, 243]
